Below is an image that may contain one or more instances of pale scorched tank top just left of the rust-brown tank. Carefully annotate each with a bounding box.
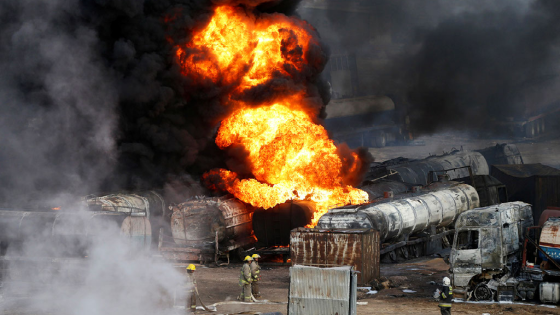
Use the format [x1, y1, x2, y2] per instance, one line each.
[85, 191, 165, 217]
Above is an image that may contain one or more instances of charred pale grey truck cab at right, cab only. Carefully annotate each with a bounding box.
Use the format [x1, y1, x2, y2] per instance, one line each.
[449, 202, 533, 300]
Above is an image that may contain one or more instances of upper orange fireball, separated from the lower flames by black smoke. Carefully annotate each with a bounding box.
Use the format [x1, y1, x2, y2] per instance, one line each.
[177, 6, 315, 92]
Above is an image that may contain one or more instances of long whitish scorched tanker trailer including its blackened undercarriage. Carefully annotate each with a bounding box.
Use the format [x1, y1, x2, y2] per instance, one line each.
[317, 182, 479, 261]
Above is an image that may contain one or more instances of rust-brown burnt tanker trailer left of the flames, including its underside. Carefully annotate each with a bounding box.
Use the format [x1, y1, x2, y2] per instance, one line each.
[158, 197, 256, 262]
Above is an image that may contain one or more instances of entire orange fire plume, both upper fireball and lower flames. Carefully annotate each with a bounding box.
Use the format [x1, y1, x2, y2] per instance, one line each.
[177, 6, 367, 226]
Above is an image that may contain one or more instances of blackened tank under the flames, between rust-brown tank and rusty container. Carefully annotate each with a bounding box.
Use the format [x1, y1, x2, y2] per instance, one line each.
[253, 201, 315, 247]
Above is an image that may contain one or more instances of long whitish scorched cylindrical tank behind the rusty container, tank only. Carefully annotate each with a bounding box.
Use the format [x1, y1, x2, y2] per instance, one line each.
[317, 184, 479, 241]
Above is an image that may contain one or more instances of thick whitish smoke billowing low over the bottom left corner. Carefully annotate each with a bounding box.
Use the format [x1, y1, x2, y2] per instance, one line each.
[0, 207, 186, 315]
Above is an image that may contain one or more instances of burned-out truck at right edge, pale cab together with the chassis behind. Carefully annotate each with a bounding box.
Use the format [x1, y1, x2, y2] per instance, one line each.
[449, 201, 560, 304]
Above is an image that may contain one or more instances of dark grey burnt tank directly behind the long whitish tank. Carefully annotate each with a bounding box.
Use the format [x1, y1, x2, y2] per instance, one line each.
[377, 151, 489, 186]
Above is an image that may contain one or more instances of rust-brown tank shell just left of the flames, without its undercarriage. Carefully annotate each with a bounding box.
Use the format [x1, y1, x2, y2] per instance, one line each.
[171, 198, 253, 245]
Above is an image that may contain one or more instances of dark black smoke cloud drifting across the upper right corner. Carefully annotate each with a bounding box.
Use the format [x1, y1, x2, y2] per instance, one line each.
[403, 1, 560, 133]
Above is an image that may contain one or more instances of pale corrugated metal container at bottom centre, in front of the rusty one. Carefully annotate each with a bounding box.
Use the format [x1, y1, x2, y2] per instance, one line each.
[288, 265, 357, 315]
